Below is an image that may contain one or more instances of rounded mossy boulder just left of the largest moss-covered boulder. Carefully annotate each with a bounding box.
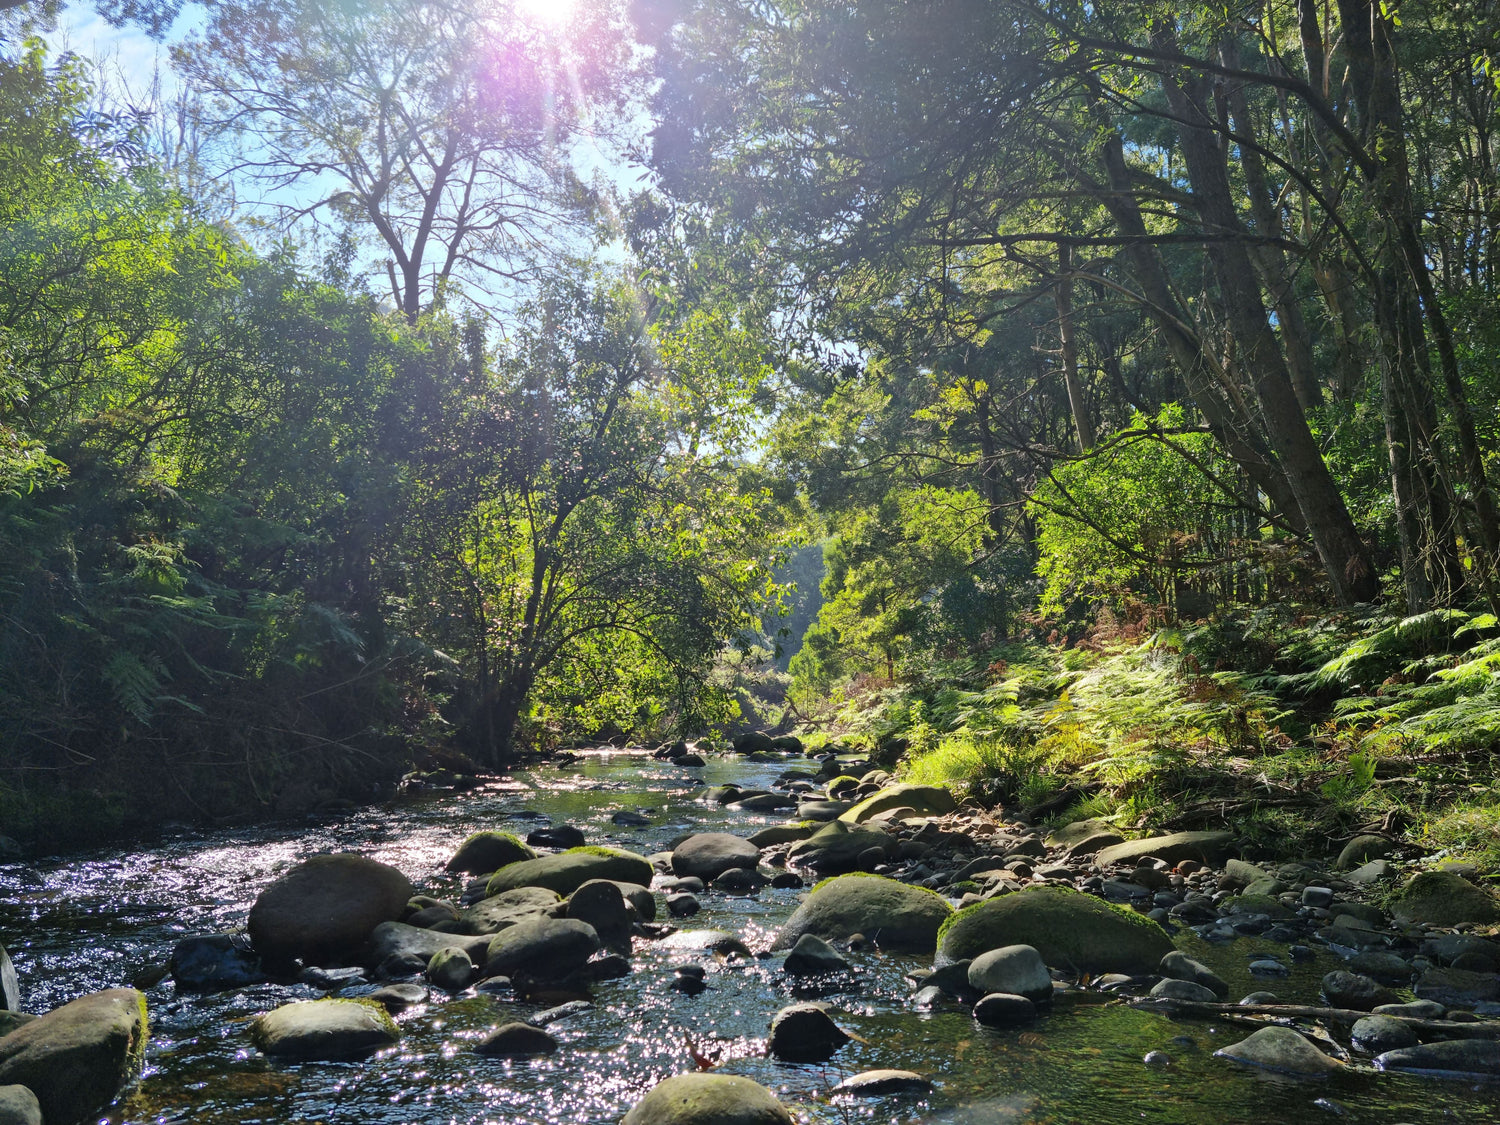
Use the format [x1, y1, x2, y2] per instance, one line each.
[771, 875, 953, 954]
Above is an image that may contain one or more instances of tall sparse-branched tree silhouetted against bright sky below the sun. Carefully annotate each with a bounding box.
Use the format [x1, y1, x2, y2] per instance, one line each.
[176, 0, 629, 323]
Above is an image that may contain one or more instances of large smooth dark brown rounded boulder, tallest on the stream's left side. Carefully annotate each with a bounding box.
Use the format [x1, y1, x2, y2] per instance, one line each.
[249, 854, 413, 966]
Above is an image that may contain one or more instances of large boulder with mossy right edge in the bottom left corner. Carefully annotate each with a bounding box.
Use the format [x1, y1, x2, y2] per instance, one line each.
[0, 989, 147, 1125]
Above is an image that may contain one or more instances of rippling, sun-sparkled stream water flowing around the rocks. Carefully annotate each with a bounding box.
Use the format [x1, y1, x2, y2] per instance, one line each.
[0, 753, 1500, 1125]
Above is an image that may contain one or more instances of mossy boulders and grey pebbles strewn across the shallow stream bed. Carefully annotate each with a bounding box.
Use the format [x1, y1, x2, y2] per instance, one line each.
[0, 746, 1500, 1125]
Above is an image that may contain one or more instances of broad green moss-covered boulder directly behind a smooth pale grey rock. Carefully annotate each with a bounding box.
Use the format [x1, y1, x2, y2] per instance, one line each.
[933, 887, 1173, 974]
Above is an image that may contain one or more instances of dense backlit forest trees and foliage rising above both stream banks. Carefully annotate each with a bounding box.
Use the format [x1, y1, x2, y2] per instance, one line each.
[0, 0, 1500, 833]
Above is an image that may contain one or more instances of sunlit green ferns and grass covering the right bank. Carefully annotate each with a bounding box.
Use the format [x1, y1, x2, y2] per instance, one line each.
[804, 608, 1500, 870]
